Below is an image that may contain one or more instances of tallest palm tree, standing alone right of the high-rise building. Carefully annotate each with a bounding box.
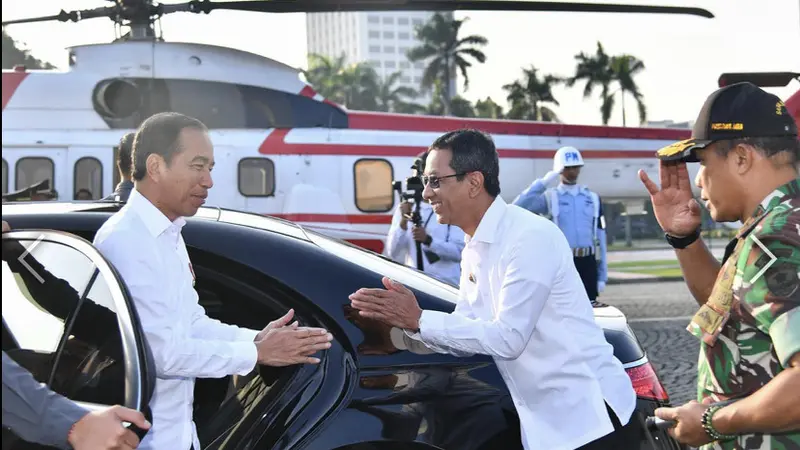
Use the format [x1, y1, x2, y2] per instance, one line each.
[407, 13, 489, 115]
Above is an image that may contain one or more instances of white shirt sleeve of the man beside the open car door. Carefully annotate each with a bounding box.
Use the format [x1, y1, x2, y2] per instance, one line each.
[95, 234, 258, 378]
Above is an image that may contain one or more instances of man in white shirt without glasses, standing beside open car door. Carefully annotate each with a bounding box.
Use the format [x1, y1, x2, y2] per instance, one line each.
[94, 113, 332, 450]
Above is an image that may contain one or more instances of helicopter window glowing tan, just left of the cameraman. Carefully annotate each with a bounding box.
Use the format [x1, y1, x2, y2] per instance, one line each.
[353, 158, 394, 212]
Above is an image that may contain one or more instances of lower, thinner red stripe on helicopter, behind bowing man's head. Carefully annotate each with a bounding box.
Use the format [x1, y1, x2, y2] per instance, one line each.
[258, 128, 656, 159]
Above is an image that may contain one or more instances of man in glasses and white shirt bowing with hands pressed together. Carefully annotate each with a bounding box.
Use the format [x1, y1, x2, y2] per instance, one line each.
[350, 130, 641, 450]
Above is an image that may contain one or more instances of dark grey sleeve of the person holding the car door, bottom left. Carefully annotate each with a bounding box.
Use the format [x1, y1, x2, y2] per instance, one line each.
[3, 352, 89, 449]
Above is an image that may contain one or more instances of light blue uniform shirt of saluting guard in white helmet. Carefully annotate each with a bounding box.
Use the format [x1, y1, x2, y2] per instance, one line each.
[513, 179, 608, 283]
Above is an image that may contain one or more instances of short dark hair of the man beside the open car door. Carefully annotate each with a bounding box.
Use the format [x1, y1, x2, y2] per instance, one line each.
[132, 112, 208, 181]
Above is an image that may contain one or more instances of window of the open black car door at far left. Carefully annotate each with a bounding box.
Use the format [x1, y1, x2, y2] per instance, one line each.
[2, 233, 132, 412]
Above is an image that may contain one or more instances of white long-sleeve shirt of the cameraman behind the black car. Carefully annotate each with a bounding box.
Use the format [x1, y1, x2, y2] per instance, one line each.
[385, 202, 464, 286]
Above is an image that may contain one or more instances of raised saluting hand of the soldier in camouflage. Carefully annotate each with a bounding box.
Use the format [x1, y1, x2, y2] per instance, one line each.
[639, 161, 701, 237]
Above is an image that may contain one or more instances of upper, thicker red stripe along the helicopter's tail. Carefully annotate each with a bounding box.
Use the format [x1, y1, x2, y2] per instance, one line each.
[347, 111, 691, 141]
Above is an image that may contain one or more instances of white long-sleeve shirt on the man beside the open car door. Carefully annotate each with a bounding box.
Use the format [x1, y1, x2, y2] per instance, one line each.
[94, 189, 258, 450]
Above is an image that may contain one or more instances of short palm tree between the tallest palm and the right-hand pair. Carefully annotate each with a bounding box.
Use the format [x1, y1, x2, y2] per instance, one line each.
[503, 66, 563, 122]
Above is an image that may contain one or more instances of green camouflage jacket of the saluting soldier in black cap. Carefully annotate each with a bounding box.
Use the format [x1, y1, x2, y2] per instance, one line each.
[697, 179, 800, 450]
